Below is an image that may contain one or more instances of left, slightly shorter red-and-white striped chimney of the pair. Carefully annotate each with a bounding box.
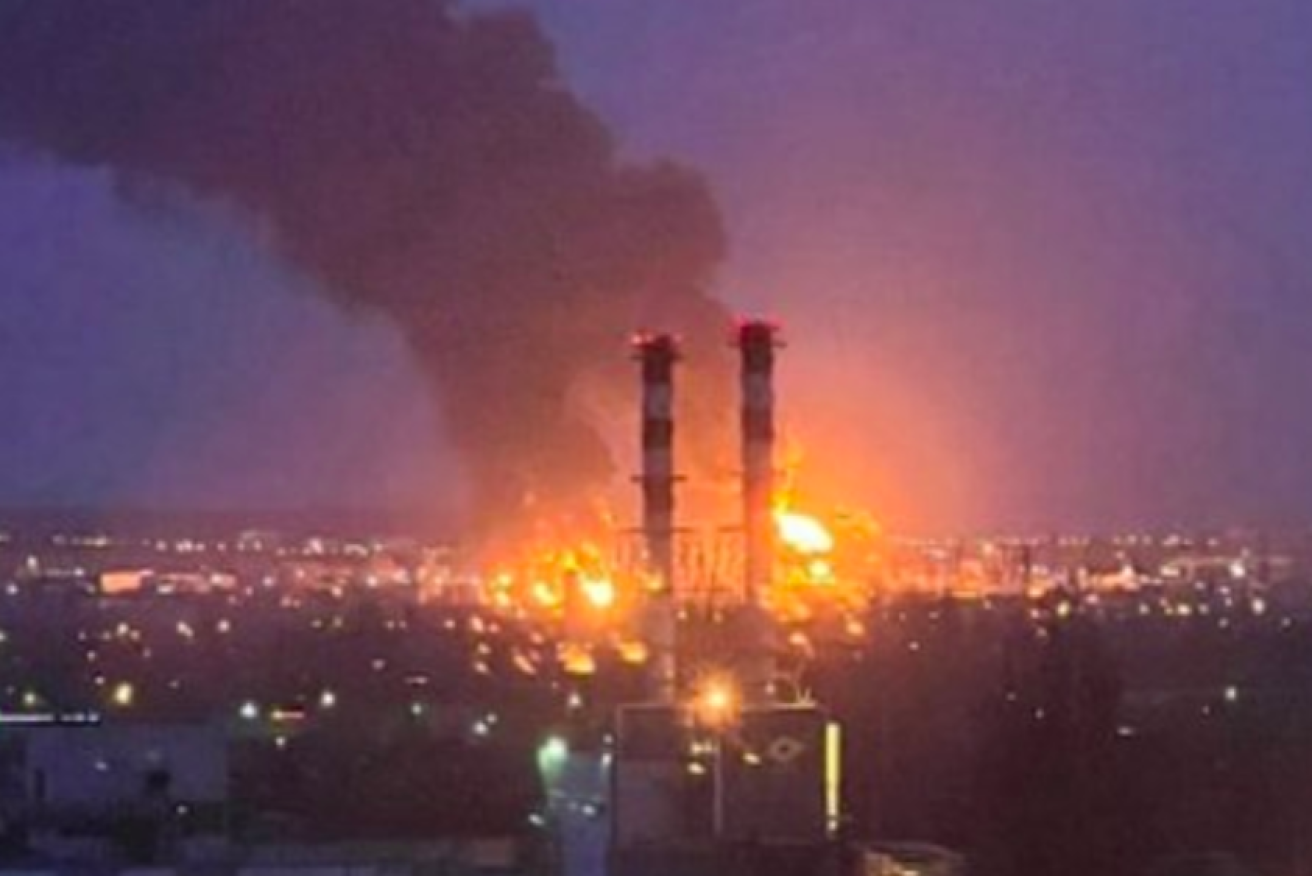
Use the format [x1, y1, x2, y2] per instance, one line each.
[634, 334, 678, 703]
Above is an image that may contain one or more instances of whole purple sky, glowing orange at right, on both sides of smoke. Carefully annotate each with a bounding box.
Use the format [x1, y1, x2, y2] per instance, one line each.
[0, 0, 1312, 531]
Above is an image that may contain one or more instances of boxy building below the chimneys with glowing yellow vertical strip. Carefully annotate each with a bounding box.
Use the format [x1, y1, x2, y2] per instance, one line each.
[610, 704, 841, 876]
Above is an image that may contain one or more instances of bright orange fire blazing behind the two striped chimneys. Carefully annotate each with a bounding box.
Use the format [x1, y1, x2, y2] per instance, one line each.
[464, 489, 874, 677]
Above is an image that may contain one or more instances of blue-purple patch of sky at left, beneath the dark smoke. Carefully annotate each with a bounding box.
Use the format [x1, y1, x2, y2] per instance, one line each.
[0, 161, 461, 510]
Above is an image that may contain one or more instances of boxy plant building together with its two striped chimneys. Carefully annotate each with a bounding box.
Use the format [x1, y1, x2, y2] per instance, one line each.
[527, 320, 841, 876]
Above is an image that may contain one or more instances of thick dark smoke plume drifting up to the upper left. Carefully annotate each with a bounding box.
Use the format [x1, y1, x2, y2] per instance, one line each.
[0, 0, 726, 527]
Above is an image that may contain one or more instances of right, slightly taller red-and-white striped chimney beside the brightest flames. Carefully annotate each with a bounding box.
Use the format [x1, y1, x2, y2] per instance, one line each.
[737, 320, 779, 696]
